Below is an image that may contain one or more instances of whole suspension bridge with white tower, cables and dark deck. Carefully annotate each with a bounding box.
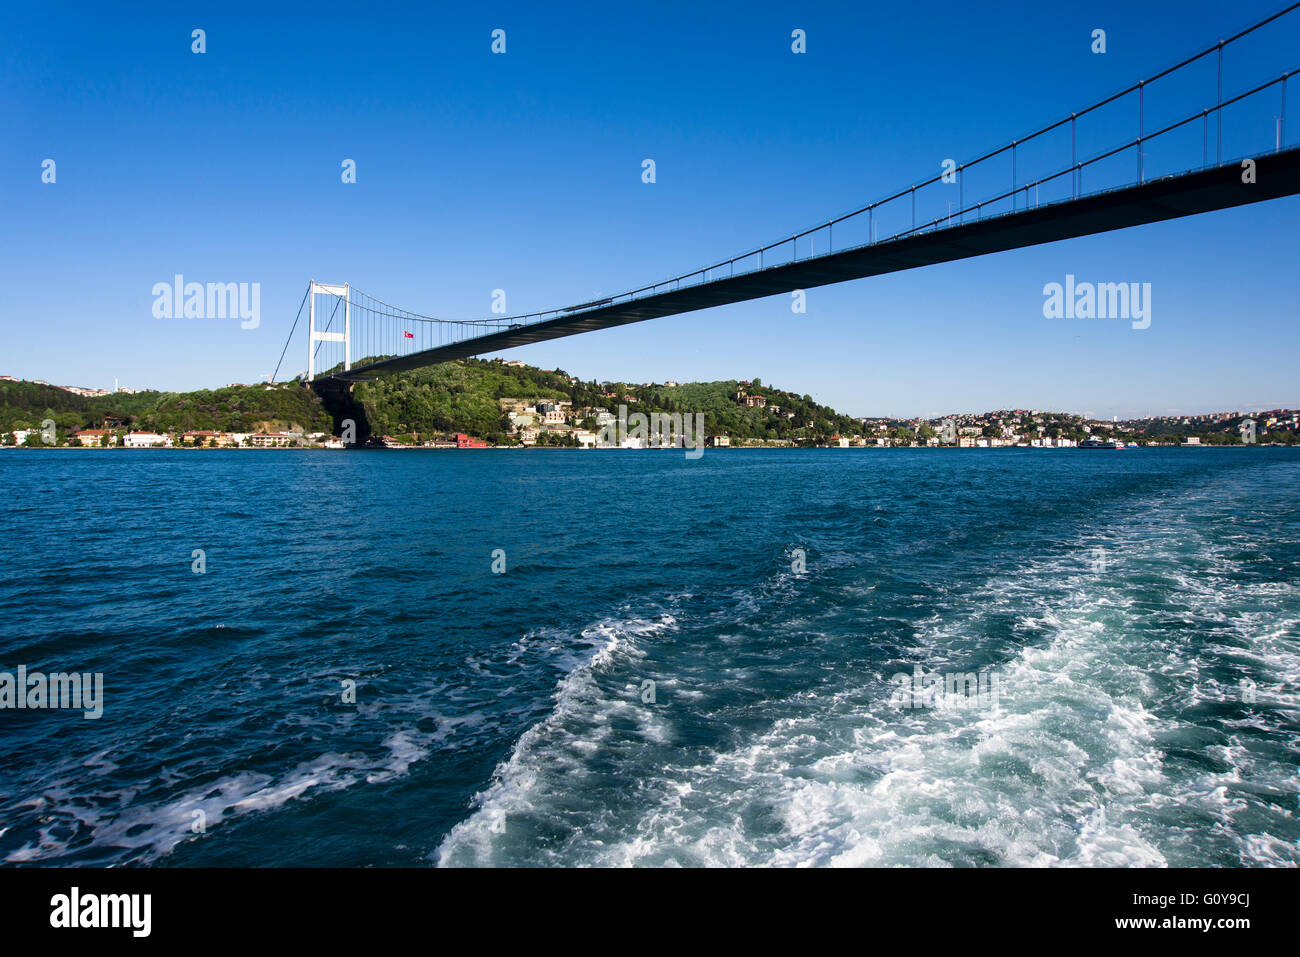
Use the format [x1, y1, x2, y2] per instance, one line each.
[277, 3, 1300, 389]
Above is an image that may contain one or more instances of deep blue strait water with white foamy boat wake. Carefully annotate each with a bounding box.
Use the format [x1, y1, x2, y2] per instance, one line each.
[0, 449, 1300, 866]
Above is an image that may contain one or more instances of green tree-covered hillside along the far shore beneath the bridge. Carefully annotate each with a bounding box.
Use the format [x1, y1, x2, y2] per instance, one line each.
[0, 359, 1300, 445]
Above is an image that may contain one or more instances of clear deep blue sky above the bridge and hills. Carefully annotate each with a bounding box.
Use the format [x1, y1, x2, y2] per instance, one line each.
[0, 0, 1300, 416]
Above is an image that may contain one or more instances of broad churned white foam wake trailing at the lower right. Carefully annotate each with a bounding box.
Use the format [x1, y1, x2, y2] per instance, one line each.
[437, 470, 1300, 866]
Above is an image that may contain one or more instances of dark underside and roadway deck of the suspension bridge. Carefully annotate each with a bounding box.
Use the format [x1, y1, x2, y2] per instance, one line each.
[327, 147, 1300, 380]
